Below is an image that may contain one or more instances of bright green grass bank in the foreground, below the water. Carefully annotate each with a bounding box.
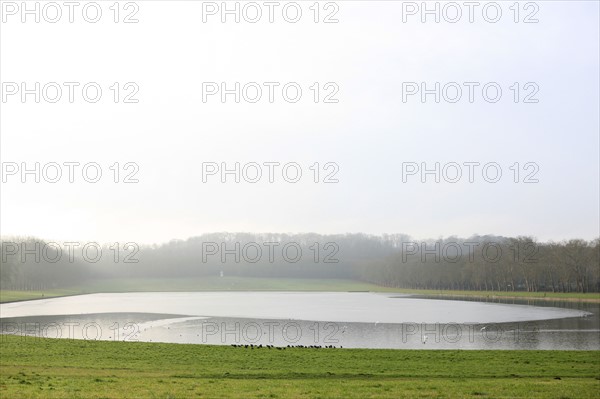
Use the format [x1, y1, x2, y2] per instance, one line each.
[0, 336, 600, 399]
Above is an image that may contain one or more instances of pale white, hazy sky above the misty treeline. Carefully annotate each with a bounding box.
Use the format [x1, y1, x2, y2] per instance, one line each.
[0, 1, 600, 243]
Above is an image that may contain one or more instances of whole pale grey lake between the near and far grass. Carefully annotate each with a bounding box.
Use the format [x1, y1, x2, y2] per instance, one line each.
[0, 292, 600, 350]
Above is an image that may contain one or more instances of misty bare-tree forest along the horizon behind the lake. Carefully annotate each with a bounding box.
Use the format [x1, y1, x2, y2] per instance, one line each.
[0, 233, 600, 292]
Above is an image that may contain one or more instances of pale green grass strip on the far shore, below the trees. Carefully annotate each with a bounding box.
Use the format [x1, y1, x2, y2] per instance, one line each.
[0, 277, 600, 303]
